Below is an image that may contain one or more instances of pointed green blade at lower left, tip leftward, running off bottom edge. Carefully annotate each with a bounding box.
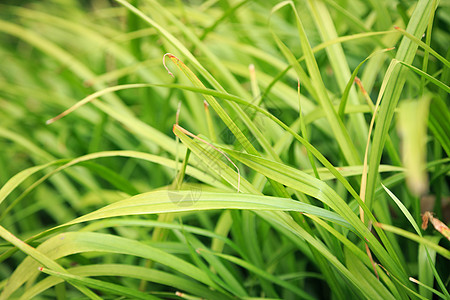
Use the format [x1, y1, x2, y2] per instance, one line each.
[39, 267, 161, 300]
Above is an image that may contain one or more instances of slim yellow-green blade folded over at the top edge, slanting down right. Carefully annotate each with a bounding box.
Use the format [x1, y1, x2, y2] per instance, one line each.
[272, 1, 360, 165]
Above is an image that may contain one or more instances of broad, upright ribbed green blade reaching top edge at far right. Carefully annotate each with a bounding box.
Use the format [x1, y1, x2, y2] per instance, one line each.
[366, 0, 434, 208]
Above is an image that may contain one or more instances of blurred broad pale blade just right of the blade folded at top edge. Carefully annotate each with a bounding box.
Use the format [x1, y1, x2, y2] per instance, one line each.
[308, 0, 368, 153]
